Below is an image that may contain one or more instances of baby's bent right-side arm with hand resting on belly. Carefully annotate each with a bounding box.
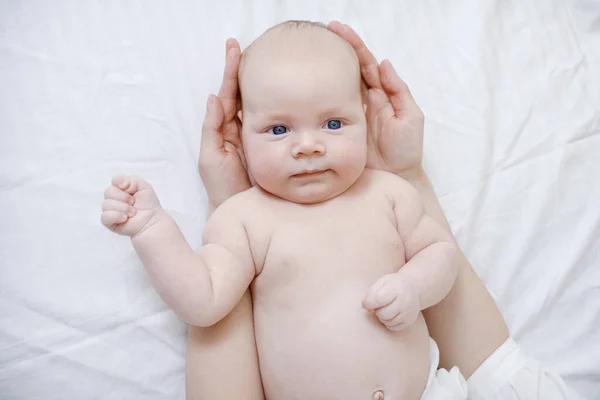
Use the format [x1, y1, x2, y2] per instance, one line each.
[363, 177, 458, 330]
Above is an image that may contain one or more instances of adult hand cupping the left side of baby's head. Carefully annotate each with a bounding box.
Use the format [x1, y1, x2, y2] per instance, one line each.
[198, 39, 250, 208]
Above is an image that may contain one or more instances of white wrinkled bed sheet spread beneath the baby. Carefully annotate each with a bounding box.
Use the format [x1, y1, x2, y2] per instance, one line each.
[0, 0, 600, 400]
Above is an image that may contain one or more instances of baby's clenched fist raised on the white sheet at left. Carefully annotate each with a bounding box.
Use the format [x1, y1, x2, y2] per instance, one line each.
[101, 176, 163, 236]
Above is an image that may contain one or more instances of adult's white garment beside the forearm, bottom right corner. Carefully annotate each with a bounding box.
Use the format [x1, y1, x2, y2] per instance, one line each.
[467, 338, 569, 400]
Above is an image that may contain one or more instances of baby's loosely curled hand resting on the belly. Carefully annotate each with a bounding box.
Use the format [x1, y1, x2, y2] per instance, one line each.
[362, 273, 421, 331]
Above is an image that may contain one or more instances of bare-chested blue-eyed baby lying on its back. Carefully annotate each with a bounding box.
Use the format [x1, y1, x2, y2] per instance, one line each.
[102, 22, 465, 400]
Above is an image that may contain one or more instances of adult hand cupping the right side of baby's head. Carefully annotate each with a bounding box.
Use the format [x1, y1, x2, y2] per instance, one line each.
[328, 21, 424, 179]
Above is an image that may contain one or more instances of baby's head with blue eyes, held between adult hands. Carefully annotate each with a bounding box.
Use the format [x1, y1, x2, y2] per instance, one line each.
[239, 21, 367, 203]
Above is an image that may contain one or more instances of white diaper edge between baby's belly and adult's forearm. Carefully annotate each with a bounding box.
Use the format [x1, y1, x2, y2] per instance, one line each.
[421, 338, 470, 400]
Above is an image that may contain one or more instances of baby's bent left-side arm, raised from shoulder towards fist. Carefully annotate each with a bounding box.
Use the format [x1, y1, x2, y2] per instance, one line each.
[102, 177, 255, 326]
